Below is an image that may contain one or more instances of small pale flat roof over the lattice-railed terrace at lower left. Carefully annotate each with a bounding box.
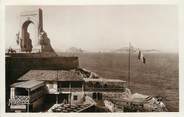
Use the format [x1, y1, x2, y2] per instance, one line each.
[11, 80, 44, 90]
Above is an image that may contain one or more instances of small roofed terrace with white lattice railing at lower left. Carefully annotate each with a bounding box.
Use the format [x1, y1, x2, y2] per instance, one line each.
[9, 80, 44, 110]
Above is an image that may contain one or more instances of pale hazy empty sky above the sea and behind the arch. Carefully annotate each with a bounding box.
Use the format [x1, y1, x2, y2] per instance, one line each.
[5, 5, 178, 52]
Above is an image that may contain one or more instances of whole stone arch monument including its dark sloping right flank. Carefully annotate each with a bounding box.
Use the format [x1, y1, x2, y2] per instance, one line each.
[17, 9, 55, 53]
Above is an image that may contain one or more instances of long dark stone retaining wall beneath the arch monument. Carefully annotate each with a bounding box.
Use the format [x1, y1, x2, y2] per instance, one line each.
[6, 56, 79, 82]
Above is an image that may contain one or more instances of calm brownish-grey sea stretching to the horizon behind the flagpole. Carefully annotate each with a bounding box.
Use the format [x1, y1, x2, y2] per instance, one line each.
[57, 53, 179, 111]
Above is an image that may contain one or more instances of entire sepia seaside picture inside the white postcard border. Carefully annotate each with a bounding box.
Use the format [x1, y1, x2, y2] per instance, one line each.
[0, 0, 183, 114]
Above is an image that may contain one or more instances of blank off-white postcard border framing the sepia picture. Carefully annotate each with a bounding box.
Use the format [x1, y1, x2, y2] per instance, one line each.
[0, 0, 184, 117]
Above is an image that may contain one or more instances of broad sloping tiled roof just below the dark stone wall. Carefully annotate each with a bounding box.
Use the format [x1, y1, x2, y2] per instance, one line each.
[18, 70, 83, 81]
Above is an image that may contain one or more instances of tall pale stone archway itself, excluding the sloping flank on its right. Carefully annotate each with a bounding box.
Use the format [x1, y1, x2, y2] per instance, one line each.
[20, 9, 43, 52]
